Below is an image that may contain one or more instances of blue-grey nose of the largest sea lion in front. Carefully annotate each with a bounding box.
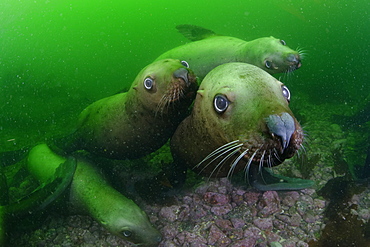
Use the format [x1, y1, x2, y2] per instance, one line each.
[266, 112, 295, 151]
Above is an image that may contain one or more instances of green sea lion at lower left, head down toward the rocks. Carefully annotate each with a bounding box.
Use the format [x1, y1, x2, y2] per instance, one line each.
[27, 144, 162, 246]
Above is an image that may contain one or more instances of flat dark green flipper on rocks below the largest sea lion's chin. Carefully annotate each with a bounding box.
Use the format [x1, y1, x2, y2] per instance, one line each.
[249, 166, 315, 191]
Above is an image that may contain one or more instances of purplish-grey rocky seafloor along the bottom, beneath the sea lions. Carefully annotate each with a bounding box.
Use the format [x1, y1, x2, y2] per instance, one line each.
[10, 179, 370, 247]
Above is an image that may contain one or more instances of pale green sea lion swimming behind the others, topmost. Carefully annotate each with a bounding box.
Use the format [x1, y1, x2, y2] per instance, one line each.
[155, 25, 302, 79]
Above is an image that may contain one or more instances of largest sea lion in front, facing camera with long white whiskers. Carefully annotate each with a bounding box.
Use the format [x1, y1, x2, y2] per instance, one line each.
[171, 63, 312, 190]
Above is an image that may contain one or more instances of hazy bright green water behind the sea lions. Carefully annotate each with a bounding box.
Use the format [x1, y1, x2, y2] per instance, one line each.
[0, 0, 370, 247]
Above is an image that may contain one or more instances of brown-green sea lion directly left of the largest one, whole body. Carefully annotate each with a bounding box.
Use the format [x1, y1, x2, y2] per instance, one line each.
[56, 59, 198, 159]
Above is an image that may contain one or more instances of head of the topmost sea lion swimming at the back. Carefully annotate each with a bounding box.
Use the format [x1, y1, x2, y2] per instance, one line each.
[244, 36, 303, 74]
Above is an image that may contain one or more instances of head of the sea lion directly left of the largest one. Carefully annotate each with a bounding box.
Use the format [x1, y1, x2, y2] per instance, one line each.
[132, 59, 198, 114]
